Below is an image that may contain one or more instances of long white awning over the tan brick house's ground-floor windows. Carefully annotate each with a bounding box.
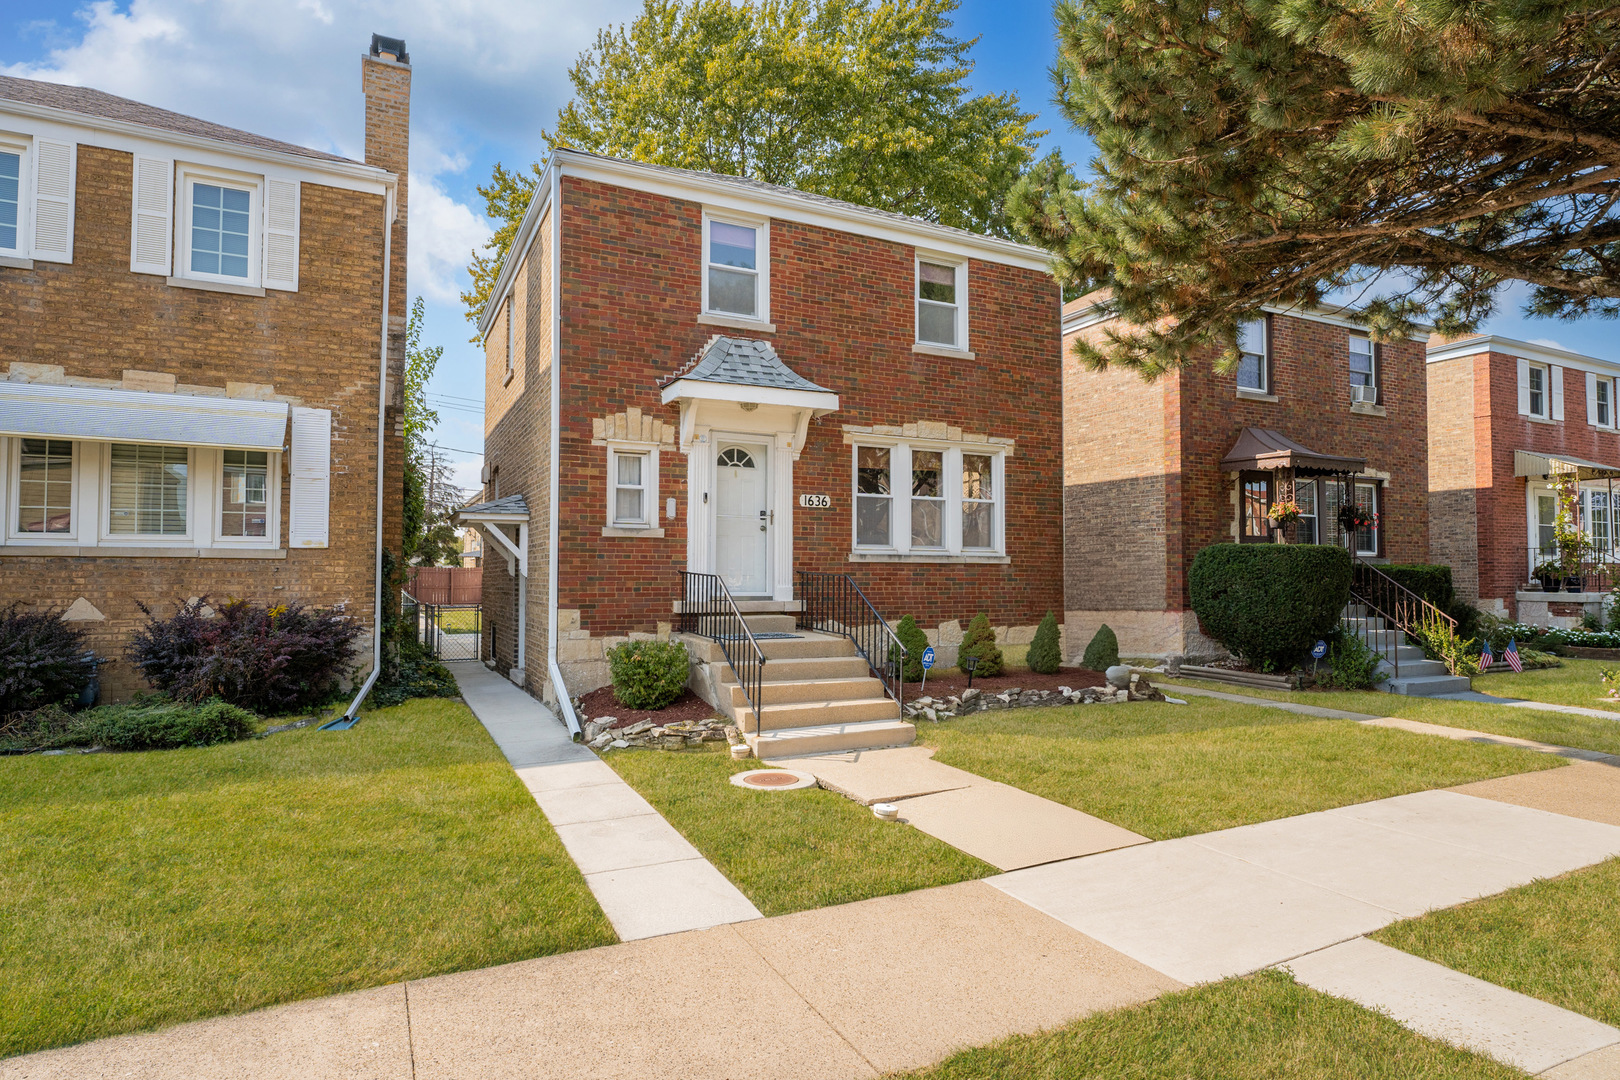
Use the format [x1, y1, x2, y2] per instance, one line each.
[0, 382, 287, 450]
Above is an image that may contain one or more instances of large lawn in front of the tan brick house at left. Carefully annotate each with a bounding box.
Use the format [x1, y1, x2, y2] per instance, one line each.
[0, 699, 616, 1056]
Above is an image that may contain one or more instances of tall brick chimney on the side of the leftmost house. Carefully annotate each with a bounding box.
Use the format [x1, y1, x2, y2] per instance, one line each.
[360, 34, 410, 552]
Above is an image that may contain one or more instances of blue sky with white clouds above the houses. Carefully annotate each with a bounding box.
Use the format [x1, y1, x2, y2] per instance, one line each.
[0, 0, 1615, 487]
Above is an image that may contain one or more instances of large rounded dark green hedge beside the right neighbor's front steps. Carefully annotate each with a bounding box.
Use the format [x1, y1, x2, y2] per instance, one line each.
[1189, 544, 1351, 670]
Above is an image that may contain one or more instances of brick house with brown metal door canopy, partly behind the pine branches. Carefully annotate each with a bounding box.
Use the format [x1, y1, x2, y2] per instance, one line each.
[1063, 293, 1429, 656]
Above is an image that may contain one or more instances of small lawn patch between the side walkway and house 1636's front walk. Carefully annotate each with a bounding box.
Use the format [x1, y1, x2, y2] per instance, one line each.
[604, 743, 996, 915]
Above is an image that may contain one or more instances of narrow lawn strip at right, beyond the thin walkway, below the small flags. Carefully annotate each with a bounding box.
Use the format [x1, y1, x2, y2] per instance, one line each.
[1153, 669, 1620, 755]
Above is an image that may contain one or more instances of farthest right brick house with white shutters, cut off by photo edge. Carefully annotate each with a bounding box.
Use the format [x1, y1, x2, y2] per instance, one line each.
[1429, 337, 1620, 625]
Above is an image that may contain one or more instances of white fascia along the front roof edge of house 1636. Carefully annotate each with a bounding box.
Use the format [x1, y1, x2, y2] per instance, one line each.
[552, 151, 1051, 274]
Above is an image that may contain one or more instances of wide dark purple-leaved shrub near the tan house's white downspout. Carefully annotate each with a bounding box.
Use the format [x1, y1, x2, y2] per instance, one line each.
[128, 596, 361, 712]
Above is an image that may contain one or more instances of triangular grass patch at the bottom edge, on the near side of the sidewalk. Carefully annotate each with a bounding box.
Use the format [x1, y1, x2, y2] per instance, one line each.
[906, 972, 1524, 1080]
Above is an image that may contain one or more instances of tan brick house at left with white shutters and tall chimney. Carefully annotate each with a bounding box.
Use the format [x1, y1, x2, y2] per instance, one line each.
[0, 39, 411, 698]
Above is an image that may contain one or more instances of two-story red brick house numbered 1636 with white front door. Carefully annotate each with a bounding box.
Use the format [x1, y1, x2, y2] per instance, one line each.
[462, 151, 1063, 757]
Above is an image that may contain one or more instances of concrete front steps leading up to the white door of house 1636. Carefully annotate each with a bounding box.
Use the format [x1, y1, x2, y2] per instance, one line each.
[680, 614, 917, 758]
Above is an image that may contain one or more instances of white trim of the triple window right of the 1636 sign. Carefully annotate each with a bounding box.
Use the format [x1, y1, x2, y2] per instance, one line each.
[849, 437, 1008, 560]
